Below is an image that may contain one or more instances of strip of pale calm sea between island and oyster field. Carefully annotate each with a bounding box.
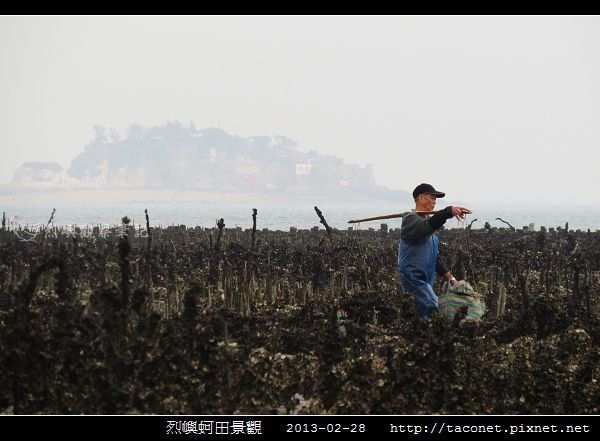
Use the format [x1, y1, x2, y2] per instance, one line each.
[0, 201, 600, 231]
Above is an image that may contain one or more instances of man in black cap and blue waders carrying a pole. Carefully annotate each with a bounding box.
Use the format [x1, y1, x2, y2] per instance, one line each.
[398, 184, 470, 319]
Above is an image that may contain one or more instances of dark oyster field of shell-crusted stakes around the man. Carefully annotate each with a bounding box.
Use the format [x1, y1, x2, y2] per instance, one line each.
[0, 218, 600, 415]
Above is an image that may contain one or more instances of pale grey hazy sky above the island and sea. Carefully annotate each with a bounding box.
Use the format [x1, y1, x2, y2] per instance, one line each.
[0, 16, 600, 205]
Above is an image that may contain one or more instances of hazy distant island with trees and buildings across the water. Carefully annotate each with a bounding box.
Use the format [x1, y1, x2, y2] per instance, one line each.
[3, 121, 410, 202]
